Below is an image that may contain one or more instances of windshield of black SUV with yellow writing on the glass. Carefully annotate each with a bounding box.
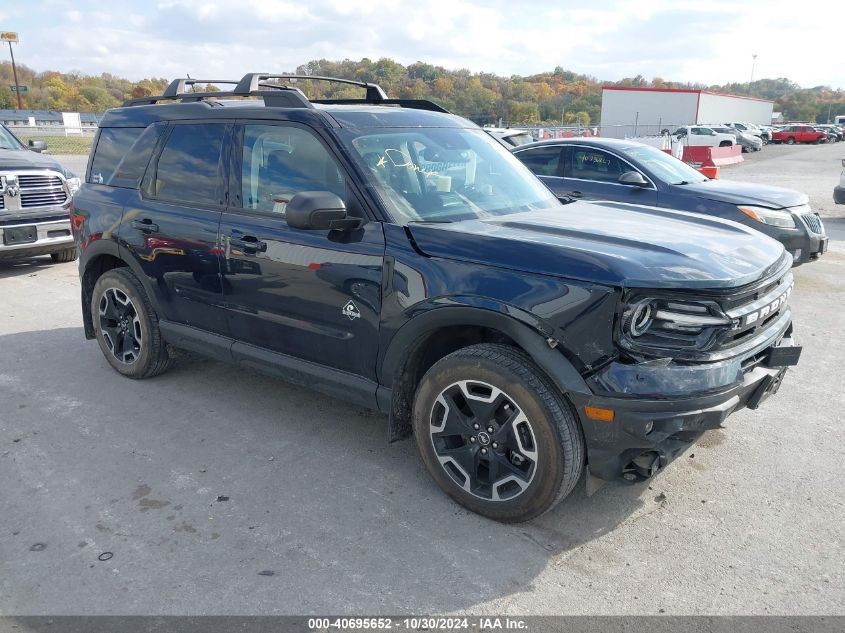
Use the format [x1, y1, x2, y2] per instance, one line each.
[341, 128, 560, 224]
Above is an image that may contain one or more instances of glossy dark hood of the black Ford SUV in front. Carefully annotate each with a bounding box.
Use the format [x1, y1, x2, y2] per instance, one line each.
[409, 202, 791, 288]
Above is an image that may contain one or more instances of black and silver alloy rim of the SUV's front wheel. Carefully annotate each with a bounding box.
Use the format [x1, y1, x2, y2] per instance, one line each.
[429, 380, 538, 501]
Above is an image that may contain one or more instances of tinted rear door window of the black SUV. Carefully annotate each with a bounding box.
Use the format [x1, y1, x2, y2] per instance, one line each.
[153, 123, 226, 205]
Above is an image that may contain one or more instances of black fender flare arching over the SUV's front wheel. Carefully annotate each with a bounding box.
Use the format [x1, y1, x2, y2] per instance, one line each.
[378, 297, 592, 441]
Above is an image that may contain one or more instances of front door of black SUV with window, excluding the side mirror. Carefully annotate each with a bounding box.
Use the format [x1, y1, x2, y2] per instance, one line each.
[220, 123, 384, 379]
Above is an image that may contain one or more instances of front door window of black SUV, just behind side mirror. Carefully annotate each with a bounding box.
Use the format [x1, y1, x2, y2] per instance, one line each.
[242, 125, 346, 217]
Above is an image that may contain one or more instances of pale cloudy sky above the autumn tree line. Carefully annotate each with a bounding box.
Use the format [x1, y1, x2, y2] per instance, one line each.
[0, 0, 845, 88]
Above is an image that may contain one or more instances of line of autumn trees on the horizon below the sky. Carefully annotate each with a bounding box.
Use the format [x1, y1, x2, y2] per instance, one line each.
[0, 58, 845, 125]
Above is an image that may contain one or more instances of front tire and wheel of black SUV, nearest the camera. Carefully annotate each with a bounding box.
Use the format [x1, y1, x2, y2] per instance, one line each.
[413, 344, 584, 523]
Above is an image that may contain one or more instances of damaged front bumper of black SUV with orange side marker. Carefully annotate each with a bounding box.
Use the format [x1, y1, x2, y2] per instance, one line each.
[574, 325, 801, 481]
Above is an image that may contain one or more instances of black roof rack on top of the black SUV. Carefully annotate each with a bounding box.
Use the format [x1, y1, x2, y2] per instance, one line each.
[123, 73, 448, 113]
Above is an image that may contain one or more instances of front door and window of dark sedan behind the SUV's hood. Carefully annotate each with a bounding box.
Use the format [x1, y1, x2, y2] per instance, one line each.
[562, 144, 657, 205]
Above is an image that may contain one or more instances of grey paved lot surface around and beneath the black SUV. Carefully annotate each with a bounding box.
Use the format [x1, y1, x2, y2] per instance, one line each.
[0, 144, 845, 626]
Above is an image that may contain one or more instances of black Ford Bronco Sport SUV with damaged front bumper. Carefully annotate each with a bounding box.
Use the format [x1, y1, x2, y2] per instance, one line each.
[71, 74, 800, 521]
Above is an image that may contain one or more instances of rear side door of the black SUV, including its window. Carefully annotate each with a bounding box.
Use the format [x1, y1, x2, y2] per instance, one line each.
[119, 121, 232, 334]
